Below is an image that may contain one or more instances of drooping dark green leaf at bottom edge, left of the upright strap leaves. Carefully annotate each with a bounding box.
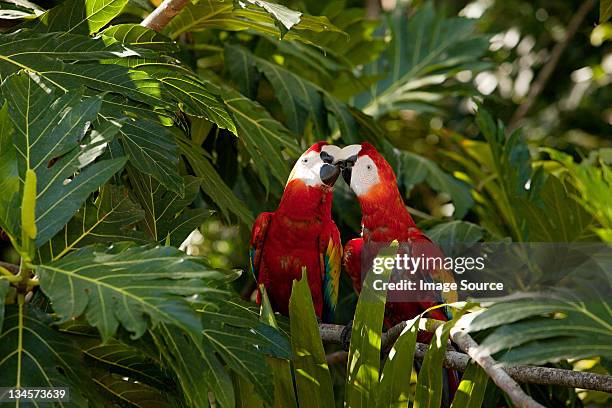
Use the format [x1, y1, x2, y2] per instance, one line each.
[151, 324, 236, 408]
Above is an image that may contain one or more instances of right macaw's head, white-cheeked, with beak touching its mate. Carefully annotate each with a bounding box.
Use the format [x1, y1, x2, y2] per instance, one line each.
[337, 142, 397, 200]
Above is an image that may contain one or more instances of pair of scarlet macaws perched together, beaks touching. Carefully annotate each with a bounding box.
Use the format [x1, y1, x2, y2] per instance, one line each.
[250, 142, 452, 326]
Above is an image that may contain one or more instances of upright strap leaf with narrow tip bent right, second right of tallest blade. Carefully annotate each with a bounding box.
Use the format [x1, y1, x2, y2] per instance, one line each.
[414, 308, 466, 408]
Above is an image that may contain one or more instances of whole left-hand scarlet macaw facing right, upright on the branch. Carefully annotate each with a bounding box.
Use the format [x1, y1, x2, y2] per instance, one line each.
[250, 142, 342, 322]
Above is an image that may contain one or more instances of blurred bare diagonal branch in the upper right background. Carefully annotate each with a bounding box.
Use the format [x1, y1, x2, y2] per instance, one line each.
[509, 0, 597, 129]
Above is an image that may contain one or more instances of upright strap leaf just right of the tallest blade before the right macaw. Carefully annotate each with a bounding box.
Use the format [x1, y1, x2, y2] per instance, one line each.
[376, 317, 419, 408]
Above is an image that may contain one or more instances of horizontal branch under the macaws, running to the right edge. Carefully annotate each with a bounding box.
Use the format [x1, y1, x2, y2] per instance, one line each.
[319, 319, 612, 393]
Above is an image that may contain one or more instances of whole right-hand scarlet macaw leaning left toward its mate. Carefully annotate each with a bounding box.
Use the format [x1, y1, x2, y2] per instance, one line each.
[338, 143, 457, 402]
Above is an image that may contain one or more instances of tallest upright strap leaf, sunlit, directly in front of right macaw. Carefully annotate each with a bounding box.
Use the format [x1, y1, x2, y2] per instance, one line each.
[344, 244, 400, 407]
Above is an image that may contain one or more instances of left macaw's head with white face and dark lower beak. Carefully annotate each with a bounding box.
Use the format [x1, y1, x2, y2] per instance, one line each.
[287, 142, 341, 189]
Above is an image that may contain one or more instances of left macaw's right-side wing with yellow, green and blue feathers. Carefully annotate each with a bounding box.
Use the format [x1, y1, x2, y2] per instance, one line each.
[319, 221, 342, 322]
